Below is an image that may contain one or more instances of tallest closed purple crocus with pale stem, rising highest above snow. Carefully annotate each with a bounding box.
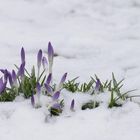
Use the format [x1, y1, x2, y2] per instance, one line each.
[48, 42, 54, 73]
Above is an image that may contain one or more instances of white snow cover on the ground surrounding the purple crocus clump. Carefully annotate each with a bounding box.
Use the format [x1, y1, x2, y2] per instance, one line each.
[0, 0, 140, 140]
